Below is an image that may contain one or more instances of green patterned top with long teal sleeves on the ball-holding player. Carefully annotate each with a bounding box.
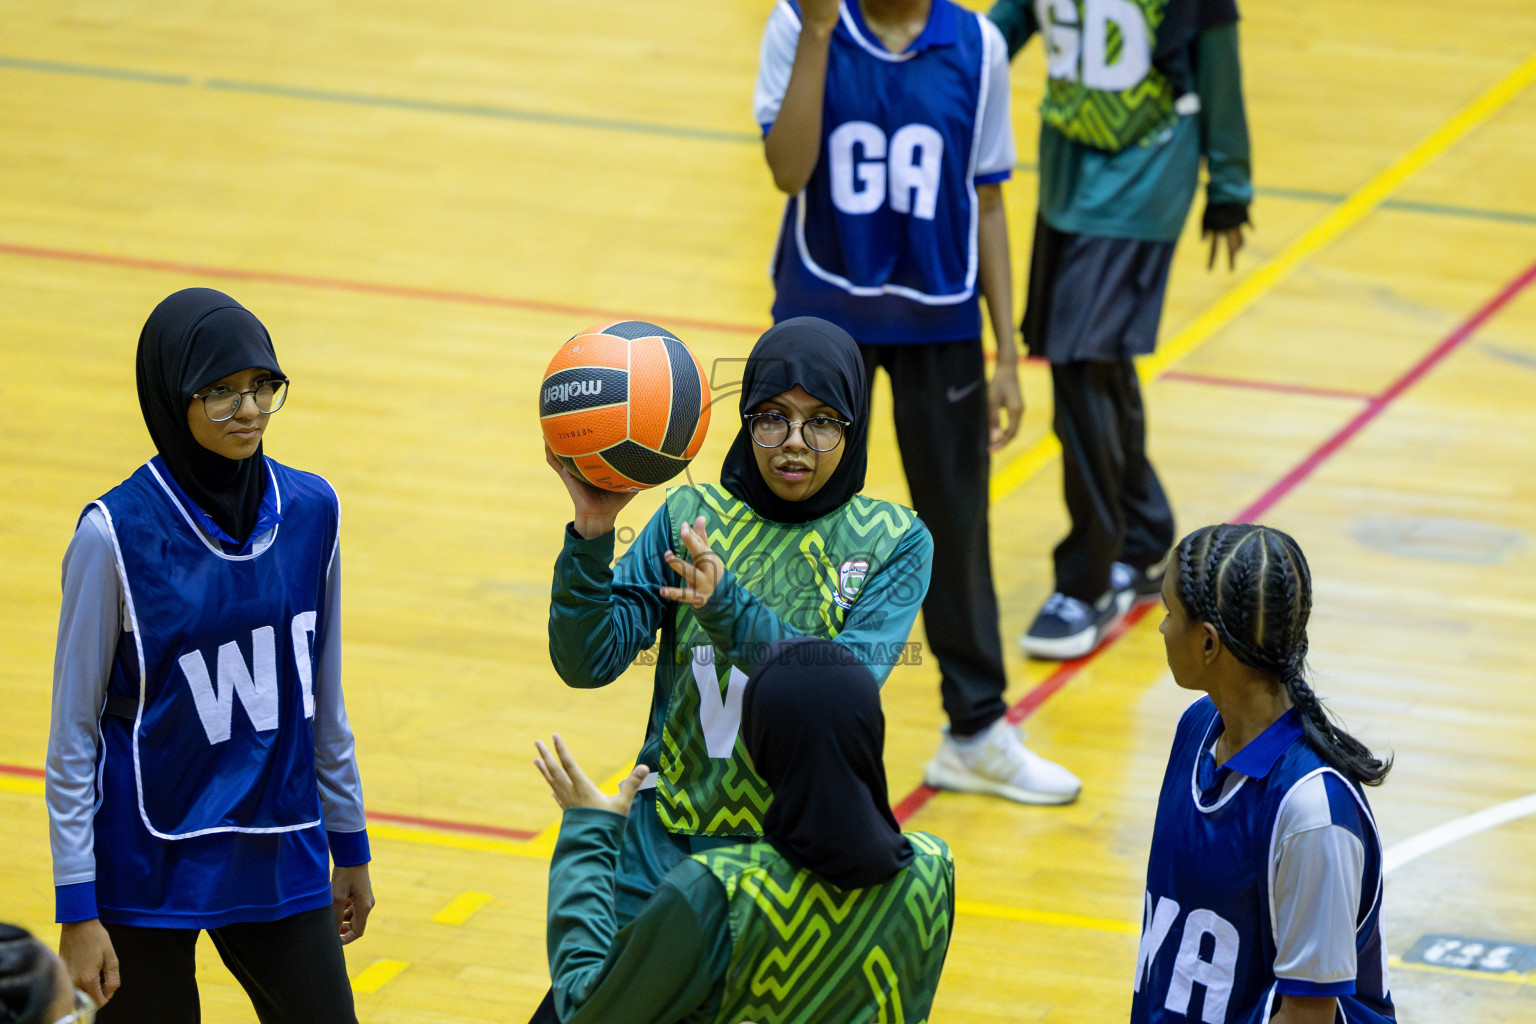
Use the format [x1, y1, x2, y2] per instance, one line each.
[548, 485, 932, 837]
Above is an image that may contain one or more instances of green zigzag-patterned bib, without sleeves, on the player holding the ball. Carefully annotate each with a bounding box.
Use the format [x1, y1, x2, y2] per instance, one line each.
[656, 484, 920, 837]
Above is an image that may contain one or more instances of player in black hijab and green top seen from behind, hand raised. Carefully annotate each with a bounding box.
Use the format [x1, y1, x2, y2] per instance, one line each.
[535, 637, 954, 1024]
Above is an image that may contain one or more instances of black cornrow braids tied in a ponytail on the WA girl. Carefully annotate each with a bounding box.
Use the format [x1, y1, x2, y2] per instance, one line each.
[1178, 524, 1392, 786]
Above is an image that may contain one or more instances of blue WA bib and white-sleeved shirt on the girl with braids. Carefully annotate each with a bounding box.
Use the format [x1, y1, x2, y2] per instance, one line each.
[1130, 697, 1395, 1024]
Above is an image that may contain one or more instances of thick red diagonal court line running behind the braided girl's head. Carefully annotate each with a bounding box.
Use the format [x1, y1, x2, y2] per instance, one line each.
[892, 256, 1536, 821]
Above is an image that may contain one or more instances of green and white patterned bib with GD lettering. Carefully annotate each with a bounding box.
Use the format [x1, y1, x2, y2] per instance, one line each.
[1037, 0, 1178, 152]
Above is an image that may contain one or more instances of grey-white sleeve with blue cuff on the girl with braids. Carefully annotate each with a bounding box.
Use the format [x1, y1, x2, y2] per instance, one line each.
[1270, 772, 1366, 996]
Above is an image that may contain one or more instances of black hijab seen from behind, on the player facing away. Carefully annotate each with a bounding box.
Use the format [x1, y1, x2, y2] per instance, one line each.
[742, 637, 914, 889]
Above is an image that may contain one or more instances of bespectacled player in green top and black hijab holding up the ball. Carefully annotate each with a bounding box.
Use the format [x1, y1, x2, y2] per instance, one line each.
[550, 318, 932, 923]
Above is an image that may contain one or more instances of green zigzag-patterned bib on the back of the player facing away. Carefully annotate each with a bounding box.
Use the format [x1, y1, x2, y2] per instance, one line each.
[694, 832, 955, 1024]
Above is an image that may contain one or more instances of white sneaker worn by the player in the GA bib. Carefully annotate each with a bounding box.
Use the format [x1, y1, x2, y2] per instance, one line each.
[923, 718, 1083, 804]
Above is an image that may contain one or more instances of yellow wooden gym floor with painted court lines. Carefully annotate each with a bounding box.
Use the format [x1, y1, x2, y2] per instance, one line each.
[0, 0, 1536, 1024]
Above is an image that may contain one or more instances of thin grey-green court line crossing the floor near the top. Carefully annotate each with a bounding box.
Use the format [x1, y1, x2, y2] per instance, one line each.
[9, 57, 1536, 224]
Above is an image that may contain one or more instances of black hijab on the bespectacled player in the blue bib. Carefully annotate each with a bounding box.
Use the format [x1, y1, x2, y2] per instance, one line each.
[137, 289, 283, 543]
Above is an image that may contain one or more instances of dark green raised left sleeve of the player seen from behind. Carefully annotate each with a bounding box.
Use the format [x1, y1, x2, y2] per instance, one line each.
[547, 808, 731, 1024]
